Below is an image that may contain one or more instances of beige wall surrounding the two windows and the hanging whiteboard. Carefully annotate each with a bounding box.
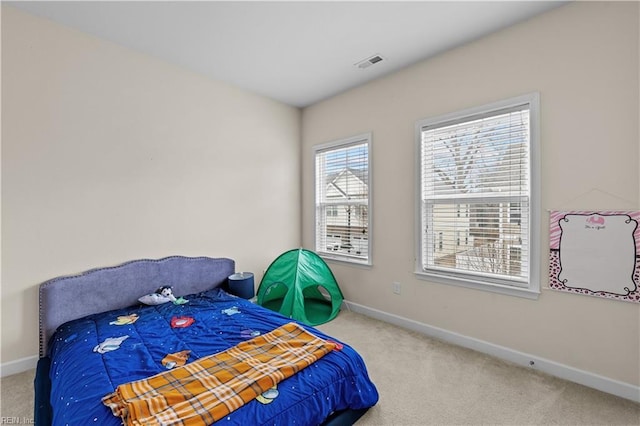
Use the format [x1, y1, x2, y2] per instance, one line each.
[302, 2, 640, 385]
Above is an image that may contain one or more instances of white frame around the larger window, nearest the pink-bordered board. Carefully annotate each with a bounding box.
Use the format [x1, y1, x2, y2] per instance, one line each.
[414, 92, 540, 299]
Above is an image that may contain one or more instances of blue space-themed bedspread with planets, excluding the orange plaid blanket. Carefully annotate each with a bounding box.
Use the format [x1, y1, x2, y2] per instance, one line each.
[50, 289, 378, 426]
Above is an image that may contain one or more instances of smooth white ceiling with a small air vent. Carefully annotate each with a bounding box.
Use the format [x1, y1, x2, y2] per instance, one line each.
[3, 1, 565, 107]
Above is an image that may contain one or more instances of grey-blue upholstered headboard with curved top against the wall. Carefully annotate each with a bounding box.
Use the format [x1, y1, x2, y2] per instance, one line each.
[39, 256, 235, 357]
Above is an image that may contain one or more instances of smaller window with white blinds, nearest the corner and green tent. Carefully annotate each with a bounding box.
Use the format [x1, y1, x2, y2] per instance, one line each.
[314, 134, 371, 264]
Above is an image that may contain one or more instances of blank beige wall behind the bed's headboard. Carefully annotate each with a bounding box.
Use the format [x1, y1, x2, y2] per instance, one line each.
[1, 5, 300, 363]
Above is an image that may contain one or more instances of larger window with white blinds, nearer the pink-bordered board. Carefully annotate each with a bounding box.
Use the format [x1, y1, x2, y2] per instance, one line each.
[416, 94, 540, 298]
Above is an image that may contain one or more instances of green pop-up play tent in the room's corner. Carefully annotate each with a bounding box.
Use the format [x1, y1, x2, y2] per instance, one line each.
[257, 248, 344, 325]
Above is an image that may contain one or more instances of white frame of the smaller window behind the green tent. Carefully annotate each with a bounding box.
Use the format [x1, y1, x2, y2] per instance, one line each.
[313, 132, 373, 266]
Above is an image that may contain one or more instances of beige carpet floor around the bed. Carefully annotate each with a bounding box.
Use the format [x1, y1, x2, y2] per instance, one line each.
[0, 311, 640, 426]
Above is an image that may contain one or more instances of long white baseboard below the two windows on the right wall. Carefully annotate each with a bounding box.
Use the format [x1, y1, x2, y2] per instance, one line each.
[343, 300, 640, 402]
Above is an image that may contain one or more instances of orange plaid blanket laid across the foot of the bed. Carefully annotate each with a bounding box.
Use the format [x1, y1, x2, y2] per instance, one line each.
[102, 323, 335, 426]
